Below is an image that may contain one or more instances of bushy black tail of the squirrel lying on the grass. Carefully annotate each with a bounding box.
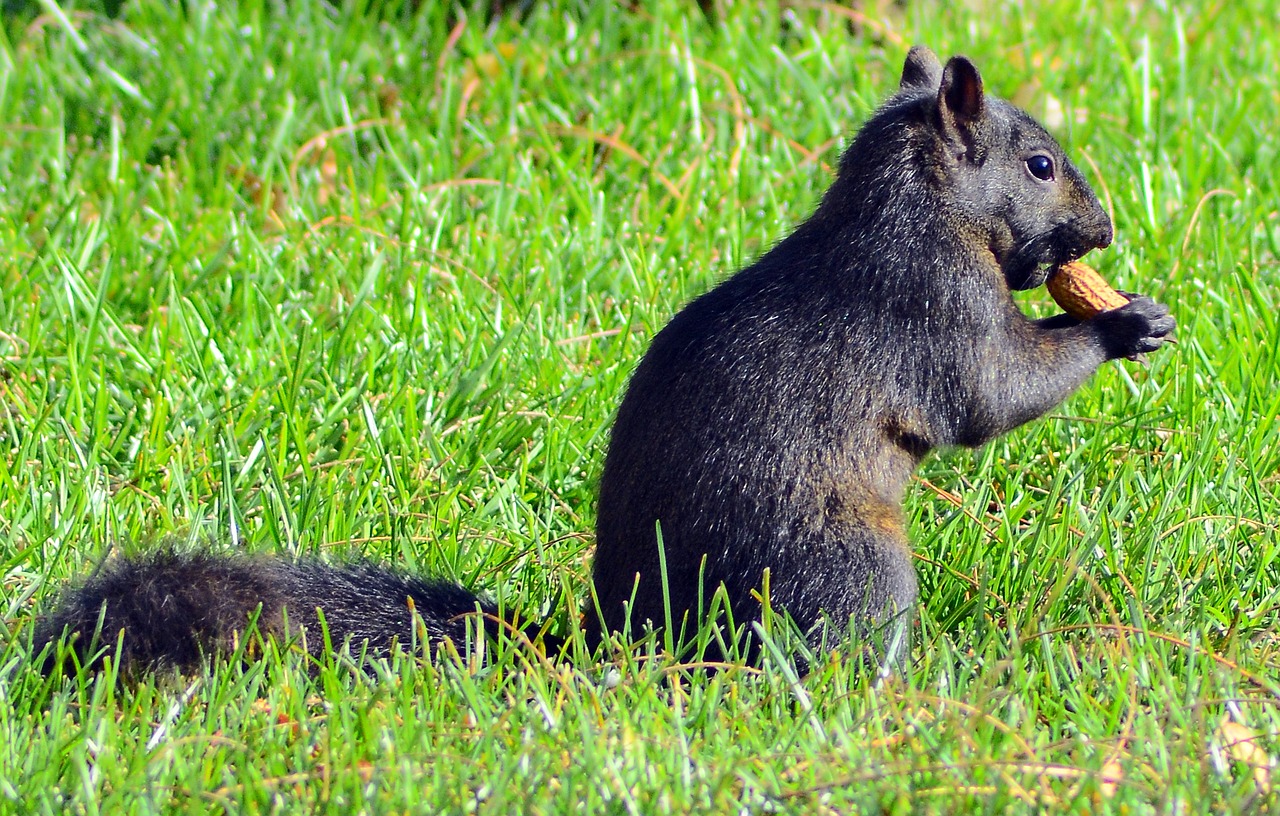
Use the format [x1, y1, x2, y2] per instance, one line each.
[35, 551, 497, 674]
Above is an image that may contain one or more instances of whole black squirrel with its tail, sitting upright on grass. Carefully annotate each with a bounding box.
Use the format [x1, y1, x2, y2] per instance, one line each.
[36, 46, 1174, 670]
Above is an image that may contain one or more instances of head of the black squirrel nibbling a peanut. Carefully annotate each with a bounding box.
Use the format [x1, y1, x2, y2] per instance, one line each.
[840, 46, 1111, 289]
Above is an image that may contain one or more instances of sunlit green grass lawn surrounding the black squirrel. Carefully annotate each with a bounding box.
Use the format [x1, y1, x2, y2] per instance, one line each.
[0, 0, 1280, 813]
